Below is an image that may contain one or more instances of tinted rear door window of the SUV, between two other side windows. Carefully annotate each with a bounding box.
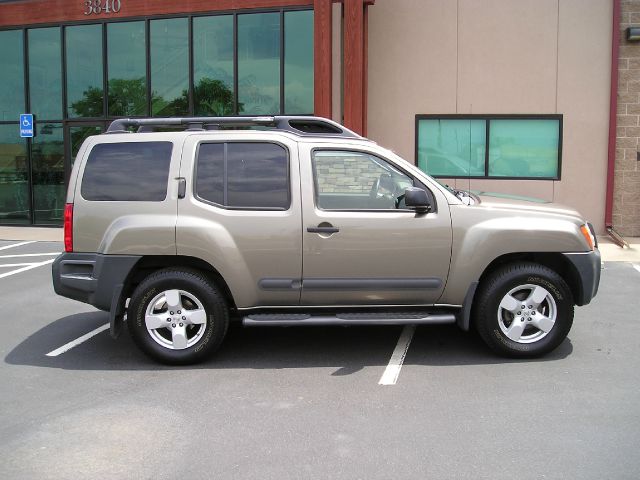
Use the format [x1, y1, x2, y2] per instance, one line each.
[196, 142, 290, 210]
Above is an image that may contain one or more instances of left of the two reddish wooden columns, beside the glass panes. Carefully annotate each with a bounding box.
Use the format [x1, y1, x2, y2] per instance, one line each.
[313, 0, 332, 118]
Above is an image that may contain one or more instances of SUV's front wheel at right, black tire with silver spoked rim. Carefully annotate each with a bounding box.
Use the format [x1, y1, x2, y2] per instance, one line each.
[473, 262, 574, 358]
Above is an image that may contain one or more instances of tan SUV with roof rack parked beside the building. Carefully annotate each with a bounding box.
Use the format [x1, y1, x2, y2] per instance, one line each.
[53, 117, 600, 364]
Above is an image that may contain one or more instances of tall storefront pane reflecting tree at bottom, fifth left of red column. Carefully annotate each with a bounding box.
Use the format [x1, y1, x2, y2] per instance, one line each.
[107, 22, 147, 117]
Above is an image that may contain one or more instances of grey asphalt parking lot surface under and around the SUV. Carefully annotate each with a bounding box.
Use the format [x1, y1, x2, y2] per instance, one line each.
[0, 241, 640, 479]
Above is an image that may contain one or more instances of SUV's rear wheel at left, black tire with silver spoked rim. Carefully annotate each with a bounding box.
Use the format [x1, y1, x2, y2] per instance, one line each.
[127, 268, 229, 365]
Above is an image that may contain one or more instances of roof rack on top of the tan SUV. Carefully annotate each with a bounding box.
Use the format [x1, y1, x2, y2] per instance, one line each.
[106, 115, 362, 138]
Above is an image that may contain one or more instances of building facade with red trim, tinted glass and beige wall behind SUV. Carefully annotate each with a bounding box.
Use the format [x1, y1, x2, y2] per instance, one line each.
[0, 0, 640, 236]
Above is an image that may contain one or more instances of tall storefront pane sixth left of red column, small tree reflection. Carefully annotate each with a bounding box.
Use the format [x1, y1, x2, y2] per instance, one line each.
[65, 25, 104, 118]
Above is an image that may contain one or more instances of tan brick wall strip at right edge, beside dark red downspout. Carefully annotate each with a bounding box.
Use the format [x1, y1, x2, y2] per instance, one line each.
[613, 0, 640, 237]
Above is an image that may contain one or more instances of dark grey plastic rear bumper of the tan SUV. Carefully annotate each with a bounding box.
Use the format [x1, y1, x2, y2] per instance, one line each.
[51, 253, 142, 311]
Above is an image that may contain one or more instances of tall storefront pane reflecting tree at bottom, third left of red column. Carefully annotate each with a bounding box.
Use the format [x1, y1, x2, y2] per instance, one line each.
[193, 15, 234, 116]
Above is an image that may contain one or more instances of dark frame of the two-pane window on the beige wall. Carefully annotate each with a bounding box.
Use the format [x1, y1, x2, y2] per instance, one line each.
[414, 113, 564, 181]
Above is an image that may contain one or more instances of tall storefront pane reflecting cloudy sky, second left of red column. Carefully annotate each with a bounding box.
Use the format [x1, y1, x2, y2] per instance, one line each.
[238, 13, 280, 115]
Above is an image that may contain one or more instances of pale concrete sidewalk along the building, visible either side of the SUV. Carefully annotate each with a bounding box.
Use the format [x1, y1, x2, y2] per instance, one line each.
[0, 227, 640, 264]
